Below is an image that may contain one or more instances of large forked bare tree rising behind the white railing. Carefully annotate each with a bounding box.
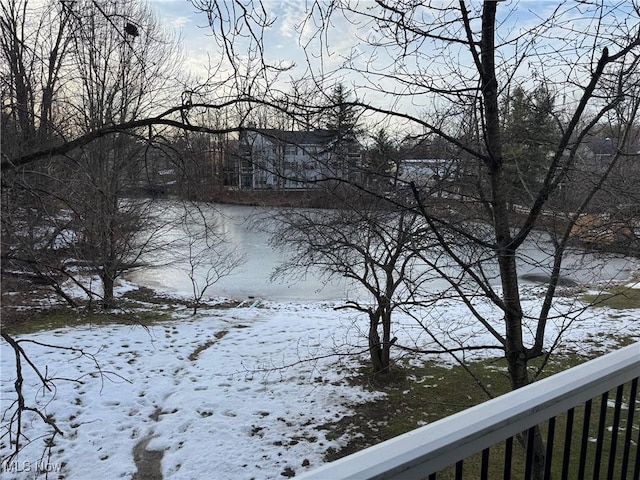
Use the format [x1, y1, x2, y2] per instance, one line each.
[194, 0, 640, 478]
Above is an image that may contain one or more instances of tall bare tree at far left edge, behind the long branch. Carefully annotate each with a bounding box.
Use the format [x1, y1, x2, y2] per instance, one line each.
[0, 0, 78, 303]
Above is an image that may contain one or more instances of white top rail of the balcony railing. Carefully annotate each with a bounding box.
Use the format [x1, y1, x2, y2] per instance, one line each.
[300, 343, 640, 480]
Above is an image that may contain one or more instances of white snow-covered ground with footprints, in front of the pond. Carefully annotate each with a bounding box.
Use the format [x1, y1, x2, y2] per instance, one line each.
[0, 280, 640, 480]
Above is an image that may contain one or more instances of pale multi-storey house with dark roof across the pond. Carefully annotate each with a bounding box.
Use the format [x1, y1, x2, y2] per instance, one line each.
[238, 129, 362, 189]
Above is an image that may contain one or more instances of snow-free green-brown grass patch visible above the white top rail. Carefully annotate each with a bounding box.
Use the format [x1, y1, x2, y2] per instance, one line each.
[321, 355, 604, 461]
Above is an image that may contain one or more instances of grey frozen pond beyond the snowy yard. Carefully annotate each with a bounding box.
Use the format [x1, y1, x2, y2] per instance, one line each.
[127, 201, 638, 301]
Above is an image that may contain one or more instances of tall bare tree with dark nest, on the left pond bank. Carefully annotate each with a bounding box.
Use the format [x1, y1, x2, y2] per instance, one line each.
[56, 0, 186, 308]
